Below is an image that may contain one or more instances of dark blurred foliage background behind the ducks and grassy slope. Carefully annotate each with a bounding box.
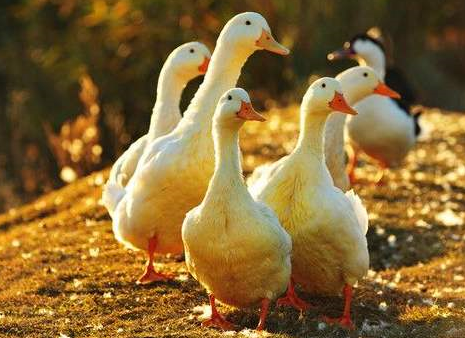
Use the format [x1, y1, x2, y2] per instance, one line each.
[0, 0, 465, 208]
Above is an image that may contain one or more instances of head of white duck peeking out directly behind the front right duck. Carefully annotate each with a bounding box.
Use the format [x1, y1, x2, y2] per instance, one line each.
[336, 66, 400, 102]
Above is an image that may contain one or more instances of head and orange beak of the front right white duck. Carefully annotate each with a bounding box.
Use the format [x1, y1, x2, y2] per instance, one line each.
[302, 77, 357, 115]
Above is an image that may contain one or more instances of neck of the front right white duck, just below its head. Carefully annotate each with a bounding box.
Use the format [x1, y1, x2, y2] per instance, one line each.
[294, 107, 328, 161]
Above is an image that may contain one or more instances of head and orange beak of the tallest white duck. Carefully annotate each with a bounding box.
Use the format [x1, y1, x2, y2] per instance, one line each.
[219, 12, 289, 55]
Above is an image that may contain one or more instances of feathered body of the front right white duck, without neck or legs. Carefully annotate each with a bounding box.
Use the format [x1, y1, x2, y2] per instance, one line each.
[251, 149, 369, 295]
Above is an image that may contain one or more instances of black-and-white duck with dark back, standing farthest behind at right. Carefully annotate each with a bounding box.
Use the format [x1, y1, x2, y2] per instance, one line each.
[328, 34, 420, 181]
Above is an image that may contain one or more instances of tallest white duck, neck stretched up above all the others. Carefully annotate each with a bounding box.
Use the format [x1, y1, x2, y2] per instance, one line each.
[107, 12, 289, 283]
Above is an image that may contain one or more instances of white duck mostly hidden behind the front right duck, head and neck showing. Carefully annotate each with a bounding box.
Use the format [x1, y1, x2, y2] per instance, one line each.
[325, 66, 399, 191]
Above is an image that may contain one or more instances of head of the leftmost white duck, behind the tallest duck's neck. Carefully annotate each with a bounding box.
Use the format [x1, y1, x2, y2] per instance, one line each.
[167, 41, 211, 80]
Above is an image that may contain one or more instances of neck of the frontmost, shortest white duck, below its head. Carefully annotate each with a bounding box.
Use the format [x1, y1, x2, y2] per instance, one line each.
[205, 124, 248, 203]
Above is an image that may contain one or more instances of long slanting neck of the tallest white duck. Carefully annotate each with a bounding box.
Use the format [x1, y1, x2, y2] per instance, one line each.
[179, 41, 253, 133]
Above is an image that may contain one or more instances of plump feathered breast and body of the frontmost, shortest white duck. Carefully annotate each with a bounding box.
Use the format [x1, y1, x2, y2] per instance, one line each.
[183, 191, 292, 307]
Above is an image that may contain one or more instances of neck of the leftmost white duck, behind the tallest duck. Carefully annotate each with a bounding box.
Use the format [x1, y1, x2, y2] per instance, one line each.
[148, 63, 188, 142]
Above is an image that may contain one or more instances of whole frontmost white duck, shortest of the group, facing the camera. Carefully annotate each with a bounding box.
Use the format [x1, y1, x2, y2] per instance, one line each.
[182, 88, 292, 330]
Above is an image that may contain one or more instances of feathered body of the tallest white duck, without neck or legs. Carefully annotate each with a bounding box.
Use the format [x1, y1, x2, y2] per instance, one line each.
[113, 130, 214, 253]
